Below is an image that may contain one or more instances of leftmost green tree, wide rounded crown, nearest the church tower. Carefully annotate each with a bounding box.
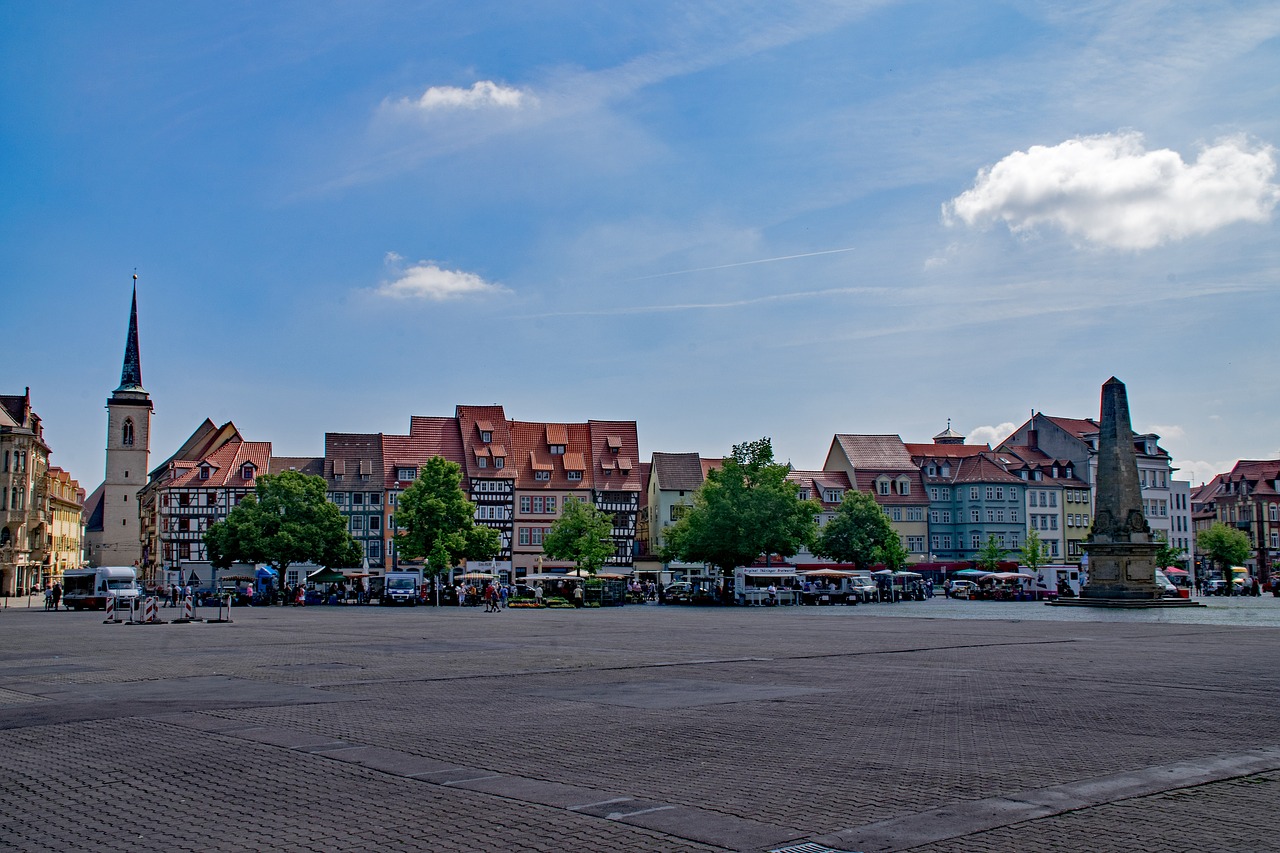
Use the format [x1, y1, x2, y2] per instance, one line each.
[205, 471, 362, 589]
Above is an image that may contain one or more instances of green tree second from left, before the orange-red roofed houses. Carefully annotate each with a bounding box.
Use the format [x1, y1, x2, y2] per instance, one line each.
[396, 456, 502, 579]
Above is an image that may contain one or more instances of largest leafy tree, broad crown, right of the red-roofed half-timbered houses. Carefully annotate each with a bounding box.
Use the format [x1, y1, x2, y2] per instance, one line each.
[663, 438, 822, 574]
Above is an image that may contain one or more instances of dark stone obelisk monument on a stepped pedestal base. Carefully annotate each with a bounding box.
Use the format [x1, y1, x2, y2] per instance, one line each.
[1051, 377, 1199, 607]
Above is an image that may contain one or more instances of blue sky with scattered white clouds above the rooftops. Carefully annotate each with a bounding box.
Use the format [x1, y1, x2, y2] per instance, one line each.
[0, 0, 1280, 489]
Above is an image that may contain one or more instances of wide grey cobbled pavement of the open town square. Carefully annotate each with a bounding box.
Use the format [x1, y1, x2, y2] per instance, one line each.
[0, 598, 1280, 853]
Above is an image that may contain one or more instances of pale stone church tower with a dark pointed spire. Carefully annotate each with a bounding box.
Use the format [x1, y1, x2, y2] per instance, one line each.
[92, 275, 152, 566]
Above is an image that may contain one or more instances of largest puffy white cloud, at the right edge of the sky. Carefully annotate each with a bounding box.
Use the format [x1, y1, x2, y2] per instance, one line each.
[942, 132, 1280, 250]
